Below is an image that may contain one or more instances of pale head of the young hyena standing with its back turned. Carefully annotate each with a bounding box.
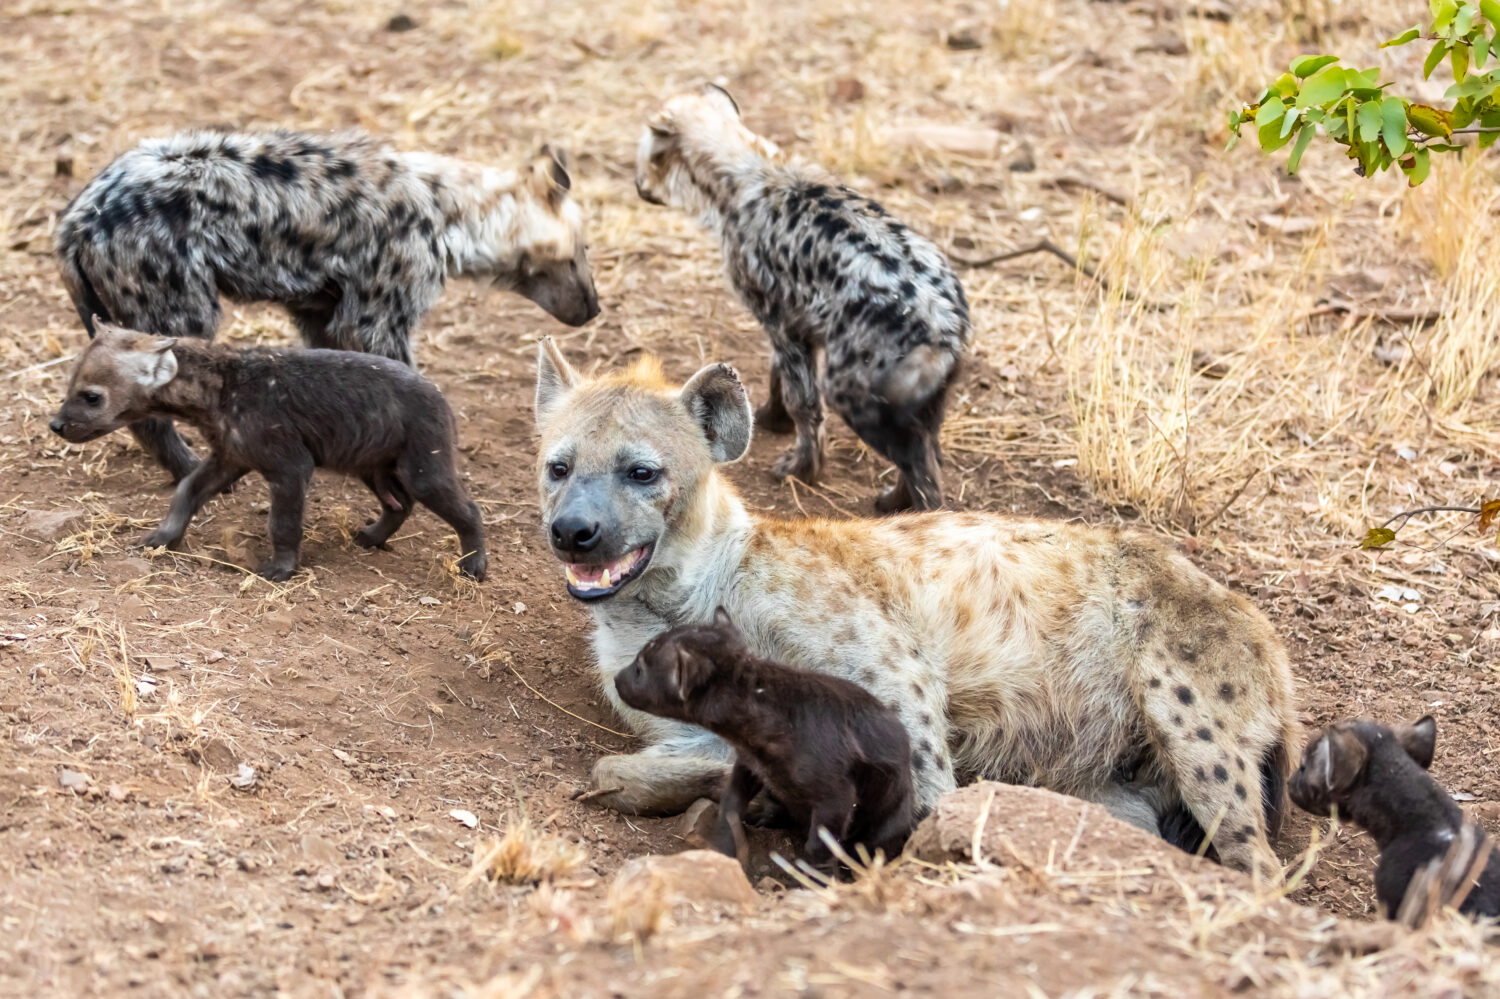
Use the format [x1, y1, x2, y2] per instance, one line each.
[636, 84, 780, 213]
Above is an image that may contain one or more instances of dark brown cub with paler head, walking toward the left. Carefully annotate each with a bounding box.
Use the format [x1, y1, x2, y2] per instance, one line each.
[51, 320, 488, 581]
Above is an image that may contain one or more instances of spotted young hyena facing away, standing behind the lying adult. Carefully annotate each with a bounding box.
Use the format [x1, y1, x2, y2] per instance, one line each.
[636, 87, 974, 512]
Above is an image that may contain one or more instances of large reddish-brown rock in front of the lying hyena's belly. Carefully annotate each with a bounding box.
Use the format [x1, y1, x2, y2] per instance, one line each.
[906, 780, 1217, 870]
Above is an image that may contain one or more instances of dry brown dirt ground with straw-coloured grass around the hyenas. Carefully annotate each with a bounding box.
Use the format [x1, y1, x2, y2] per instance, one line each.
[0, 0, 1500, 996]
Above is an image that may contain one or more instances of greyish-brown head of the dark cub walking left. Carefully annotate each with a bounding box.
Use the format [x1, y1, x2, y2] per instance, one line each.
[48, 317, 177, 444]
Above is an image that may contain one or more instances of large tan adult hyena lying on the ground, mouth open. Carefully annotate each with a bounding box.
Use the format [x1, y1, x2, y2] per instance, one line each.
[537, 339, 1296, 869]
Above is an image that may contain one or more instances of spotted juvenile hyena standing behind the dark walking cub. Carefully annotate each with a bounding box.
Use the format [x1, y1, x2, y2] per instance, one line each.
[57, 132, 599, 480]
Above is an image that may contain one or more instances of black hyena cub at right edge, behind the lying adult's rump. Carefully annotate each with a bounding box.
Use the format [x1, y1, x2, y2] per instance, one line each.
[1287, 716, 1500, 918]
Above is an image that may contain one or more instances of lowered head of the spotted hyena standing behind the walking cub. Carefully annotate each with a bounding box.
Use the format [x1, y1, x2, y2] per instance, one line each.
[495, 146, 599, 326]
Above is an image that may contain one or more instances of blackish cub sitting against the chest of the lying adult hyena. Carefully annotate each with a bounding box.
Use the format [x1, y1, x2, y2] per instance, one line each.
[615, 608, 914, 867]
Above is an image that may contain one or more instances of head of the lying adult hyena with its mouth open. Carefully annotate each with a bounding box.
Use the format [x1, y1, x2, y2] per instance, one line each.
[536, 338, 752, 600]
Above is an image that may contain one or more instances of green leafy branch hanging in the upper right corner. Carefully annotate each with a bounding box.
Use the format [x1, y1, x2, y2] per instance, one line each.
[1229, 0, 1500, 188]
